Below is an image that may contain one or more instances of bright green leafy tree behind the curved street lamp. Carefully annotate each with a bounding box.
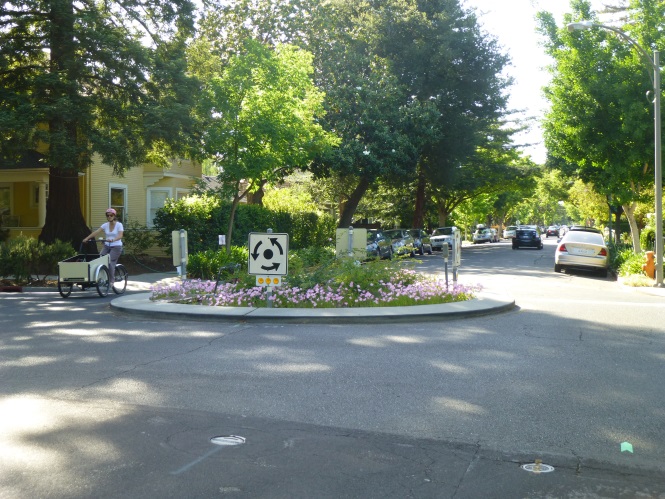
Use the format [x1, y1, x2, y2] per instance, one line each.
[539, 0, 665, 251]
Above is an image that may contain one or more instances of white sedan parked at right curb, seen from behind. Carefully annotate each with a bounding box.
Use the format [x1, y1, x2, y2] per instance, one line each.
[554, 227, 610, 277]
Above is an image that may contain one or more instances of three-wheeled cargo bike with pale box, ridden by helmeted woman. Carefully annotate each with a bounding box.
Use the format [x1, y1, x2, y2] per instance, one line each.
[58, 239, 129, 298]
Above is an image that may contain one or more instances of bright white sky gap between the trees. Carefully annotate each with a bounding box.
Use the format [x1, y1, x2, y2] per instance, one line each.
[461, 0, 600, 163]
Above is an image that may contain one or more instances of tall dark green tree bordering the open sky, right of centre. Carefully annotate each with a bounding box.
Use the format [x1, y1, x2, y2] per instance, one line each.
[376, 0, 516, 225]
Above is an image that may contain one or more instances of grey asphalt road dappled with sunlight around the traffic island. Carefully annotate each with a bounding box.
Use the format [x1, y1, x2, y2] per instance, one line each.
[0, 239, 665, 499]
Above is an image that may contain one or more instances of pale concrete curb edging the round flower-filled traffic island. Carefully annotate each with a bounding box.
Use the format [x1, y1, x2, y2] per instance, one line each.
[111, 292, 515, 324]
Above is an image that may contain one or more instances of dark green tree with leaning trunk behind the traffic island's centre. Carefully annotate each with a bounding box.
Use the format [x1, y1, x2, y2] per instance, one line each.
[308, 1, 438, 227]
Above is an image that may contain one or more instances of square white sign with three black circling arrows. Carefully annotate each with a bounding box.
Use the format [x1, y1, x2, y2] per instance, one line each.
[247, 232, 289, 275]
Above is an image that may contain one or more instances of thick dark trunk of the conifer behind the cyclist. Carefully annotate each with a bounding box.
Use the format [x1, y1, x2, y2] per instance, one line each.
[39, 167, 91, 251]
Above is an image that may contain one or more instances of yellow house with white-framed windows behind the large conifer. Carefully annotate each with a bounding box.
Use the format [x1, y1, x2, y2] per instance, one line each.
[0, 152, 202, 248]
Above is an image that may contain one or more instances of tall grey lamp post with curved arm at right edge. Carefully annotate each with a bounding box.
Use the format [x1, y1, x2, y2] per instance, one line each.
[567, 21, 663, 287]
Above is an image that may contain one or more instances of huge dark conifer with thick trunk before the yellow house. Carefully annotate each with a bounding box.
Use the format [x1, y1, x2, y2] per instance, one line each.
[0, 0, 195, 247]
